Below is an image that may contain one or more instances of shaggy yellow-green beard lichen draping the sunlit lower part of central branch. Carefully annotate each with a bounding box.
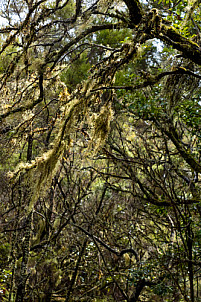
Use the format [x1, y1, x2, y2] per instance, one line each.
[6, 31, 142, 206]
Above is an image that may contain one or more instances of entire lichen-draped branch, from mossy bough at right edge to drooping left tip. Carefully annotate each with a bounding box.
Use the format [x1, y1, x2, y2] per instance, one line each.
[6, 10, 197, 203]
